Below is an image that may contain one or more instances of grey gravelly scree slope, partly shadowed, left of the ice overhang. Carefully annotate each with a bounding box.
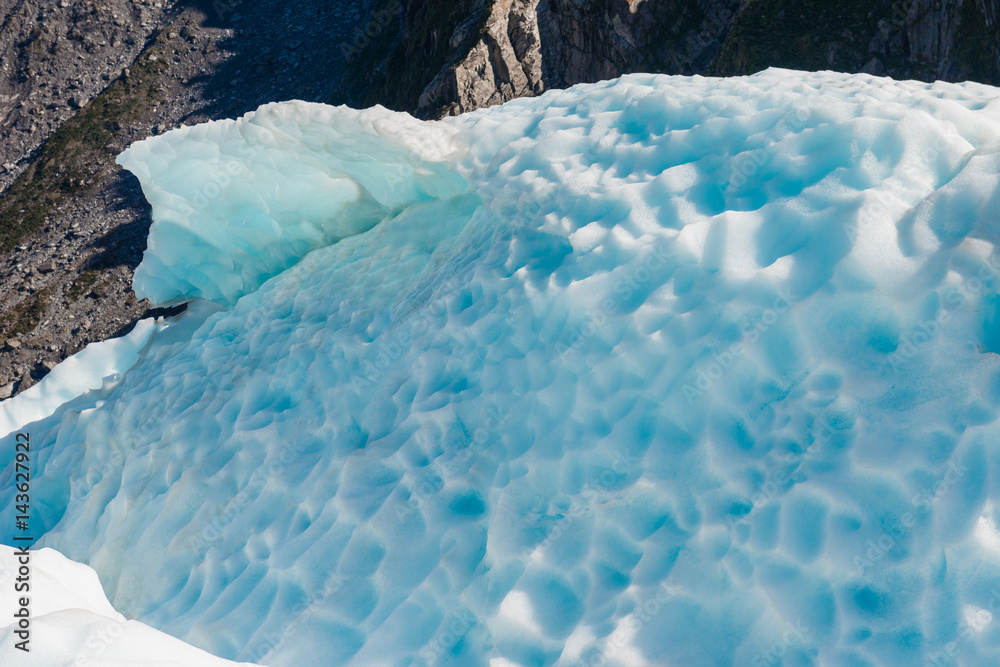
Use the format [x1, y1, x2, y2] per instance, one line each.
[0, 0, 382, 400]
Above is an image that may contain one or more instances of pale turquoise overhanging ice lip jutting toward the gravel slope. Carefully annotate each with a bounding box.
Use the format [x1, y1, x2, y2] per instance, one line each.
[117, 104, 468, 304]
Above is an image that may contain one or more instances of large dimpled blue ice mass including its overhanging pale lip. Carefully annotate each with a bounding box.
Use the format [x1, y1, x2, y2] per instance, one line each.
[0, 69, 1000, 667]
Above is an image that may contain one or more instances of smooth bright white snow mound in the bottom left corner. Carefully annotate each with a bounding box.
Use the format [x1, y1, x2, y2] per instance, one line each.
[0, 546, 254, 667]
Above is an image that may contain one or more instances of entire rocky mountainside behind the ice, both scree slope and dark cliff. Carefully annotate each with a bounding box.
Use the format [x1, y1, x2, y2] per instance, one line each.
[0, 0, 1000, 399]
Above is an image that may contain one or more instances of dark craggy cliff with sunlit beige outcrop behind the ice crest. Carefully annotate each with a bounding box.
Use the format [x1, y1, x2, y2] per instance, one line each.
[337, 0, 1000, 118]
